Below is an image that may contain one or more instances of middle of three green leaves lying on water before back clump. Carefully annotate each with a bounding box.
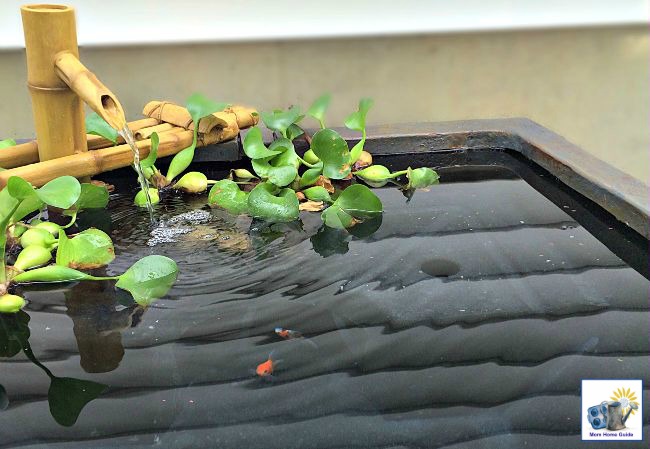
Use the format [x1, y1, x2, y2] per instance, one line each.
[248, 182, 299, 221]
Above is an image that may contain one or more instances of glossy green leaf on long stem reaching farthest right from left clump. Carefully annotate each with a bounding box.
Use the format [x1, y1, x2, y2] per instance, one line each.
[115, 255, 178, 305]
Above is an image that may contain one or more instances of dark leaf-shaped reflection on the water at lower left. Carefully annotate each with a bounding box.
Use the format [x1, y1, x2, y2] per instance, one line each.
[47, 376, 108, 427]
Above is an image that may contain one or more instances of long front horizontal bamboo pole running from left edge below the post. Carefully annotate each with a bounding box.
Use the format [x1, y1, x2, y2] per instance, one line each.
[0, 127, 239, 189]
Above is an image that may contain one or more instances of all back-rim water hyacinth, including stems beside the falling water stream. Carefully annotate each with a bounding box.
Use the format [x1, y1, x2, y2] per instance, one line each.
[83, 94, 438, 234]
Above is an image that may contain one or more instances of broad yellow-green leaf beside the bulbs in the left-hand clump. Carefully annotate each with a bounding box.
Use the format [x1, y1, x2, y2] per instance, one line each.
[56, 228, 115, 270]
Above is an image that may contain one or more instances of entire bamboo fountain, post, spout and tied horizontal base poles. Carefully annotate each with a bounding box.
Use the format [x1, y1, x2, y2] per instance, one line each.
[0, 4, 258, 188]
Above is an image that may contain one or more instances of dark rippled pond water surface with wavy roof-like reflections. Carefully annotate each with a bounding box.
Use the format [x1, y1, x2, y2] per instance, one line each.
[0, 151, 650, 449]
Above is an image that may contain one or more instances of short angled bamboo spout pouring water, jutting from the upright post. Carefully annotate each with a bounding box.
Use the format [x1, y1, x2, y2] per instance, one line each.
[54, 51, 126, 131]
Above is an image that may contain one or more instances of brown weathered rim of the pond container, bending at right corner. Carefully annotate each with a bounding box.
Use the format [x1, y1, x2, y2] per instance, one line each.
[322, 118, 650, 239]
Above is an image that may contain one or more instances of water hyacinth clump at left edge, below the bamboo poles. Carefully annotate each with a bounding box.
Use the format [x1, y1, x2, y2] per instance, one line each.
[0, 176, 178, 313]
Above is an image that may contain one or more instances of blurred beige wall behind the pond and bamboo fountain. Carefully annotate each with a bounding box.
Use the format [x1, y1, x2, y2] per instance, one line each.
[0, 27, 650, 183]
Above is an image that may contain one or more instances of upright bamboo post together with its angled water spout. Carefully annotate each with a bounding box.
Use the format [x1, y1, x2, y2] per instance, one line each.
[20, 5, 126, 161]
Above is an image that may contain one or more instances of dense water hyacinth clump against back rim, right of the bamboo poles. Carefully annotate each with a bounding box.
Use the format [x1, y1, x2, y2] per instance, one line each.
[208, 94, 438, 229]
